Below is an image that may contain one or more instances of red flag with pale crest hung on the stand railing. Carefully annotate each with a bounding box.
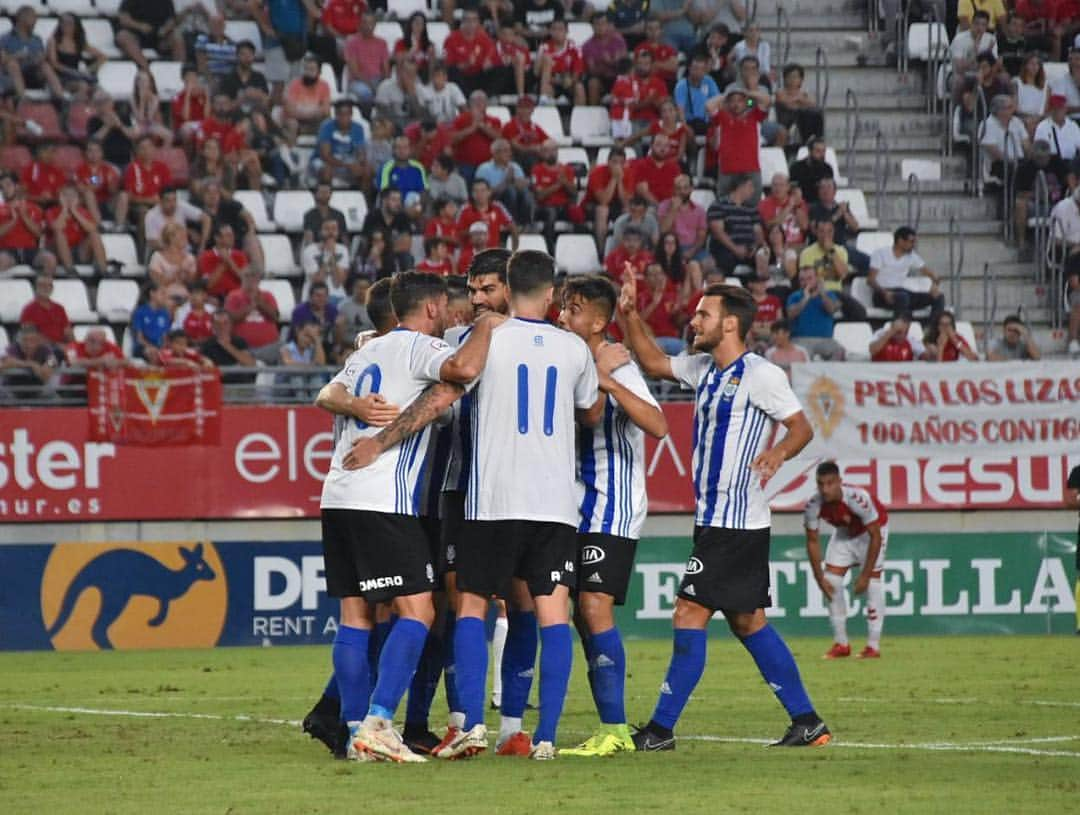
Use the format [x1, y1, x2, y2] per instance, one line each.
[86, 366, 221, 446]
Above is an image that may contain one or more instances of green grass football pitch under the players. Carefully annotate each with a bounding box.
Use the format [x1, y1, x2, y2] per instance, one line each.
[0, 639, 1080, 815]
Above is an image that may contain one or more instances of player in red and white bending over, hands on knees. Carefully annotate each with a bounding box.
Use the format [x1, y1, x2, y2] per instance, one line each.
[802, 461, 889, 660]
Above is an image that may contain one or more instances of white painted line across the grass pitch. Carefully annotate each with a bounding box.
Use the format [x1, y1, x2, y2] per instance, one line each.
[6, 705, 1080, 759]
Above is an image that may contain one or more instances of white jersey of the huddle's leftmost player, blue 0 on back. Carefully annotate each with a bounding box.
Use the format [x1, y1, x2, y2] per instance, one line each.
[320, 328, 454, 515]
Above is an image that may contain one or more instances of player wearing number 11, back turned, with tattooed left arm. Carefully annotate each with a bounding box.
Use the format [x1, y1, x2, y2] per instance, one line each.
[350, 252, 604, 760]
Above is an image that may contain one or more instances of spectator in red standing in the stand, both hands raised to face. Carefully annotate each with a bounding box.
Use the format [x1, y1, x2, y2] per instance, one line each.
[705, 85, 769, 202]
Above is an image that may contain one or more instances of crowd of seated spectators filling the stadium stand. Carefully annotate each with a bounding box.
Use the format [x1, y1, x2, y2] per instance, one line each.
[0, 0, 1058, 401]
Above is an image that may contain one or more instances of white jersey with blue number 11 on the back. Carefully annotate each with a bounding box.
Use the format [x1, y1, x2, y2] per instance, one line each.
[465, 317, 597, 529]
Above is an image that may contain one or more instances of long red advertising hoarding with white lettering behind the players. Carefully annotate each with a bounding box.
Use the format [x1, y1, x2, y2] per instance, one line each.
[0, 403, 1080, 522]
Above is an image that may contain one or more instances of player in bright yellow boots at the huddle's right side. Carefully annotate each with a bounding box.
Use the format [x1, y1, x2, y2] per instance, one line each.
[558, 277, 667, 756]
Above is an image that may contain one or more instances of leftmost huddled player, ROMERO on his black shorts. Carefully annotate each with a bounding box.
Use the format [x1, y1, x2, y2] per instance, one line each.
[321, 272, 495, 762]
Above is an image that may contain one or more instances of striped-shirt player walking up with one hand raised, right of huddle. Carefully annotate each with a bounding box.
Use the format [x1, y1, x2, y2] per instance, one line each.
[619, 274, 832, 751]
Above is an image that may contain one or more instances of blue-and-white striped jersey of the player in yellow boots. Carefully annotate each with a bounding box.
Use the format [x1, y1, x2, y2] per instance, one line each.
[578, 363, 659, 541]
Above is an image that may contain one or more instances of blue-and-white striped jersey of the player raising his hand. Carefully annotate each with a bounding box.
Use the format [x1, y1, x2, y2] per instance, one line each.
[671, 352, 802, 529]
